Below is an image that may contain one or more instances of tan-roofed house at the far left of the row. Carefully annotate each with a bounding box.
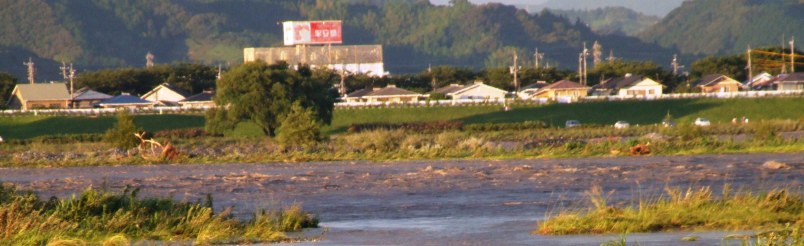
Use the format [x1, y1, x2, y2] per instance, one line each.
[6, 83, 71, 110]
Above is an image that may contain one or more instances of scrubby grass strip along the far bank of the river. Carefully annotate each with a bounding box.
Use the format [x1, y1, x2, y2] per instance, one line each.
[0, 121, 804, 167]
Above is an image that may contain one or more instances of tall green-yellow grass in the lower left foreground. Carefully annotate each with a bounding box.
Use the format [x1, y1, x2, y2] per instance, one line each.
[0, 185, 318, 245]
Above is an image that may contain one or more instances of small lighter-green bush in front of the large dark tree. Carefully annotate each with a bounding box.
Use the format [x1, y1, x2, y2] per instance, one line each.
[276, 103, 321, 148]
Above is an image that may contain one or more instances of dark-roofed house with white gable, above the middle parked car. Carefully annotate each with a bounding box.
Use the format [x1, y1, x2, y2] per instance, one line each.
[590, 74, 664, 96]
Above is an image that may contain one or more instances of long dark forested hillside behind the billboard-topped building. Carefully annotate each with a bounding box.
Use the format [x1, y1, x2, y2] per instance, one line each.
[0, 0, 674, 78]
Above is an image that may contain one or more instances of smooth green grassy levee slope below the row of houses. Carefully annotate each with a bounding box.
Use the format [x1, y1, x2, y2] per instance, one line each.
[0, 97, 804, 139]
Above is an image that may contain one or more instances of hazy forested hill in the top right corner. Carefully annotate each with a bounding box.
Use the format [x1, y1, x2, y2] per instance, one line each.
[640, 0, 804, 54]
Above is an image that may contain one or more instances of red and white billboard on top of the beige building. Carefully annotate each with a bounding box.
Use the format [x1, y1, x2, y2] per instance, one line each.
[282, 21, 343, 45]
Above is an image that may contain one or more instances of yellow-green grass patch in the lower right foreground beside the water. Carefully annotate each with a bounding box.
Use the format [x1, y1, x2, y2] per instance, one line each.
[534, 185, 804, 235]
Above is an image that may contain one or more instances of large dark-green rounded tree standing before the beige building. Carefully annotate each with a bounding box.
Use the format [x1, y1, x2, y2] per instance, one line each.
[207, 61, 335, 137]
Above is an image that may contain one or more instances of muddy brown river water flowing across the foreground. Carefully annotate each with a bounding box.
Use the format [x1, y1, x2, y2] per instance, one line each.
[0, 153, 804, 245]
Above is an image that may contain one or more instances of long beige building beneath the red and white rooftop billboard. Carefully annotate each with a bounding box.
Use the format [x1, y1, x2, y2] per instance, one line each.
[243, 45, 386, 76]
